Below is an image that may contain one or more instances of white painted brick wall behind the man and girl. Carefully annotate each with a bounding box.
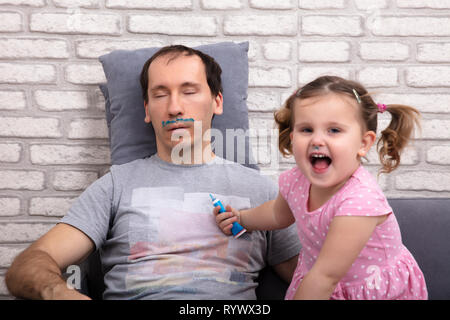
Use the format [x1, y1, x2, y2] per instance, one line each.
[0, 0, 450, 298]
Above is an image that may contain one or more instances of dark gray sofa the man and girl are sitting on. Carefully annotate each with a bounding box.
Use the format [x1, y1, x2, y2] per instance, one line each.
[81, 198, 450, 300]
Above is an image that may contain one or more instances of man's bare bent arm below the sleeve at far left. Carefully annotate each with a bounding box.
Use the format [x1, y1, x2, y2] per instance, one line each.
[5, 223, 94, 299]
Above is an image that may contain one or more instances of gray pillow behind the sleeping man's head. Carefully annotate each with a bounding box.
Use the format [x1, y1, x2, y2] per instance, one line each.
[99, 42, 258, 169]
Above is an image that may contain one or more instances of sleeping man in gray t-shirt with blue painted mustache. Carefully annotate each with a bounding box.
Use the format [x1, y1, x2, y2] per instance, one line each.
[6, 46, 299, 299]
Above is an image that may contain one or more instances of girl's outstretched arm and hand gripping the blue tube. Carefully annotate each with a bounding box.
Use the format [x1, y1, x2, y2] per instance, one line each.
[214, 193, 295, 235]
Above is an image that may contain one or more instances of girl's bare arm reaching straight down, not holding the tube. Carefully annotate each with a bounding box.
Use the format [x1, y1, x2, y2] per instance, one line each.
[294, 215, 387, 300]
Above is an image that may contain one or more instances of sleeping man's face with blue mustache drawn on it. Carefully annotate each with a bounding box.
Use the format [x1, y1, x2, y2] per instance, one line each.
[145, 54, 223, 162]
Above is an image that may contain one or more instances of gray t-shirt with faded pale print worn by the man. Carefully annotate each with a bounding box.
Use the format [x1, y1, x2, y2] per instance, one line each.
[61, 155, 300, 300]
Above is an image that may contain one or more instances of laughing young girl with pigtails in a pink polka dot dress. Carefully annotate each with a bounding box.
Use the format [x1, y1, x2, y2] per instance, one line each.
[214, 76, 427, 300]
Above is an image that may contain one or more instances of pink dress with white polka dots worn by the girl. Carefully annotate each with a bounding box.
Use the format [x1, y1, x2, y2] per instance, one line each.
[279, 166, 428, 300]
